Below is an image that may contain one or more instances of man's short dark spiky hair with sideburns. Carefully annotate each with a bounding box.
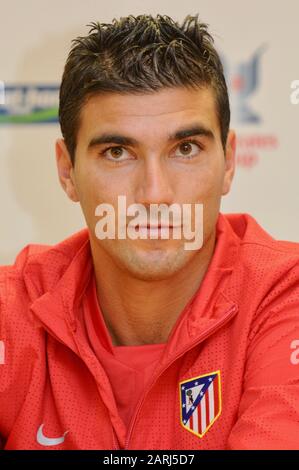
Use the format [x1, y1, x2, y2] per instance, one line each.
[59, 15, 230, 164]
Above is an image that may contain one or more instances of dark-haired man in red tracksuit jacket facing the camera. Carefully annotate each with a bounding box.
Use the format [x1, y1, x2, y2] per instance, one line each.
[0, 15, 299, 450]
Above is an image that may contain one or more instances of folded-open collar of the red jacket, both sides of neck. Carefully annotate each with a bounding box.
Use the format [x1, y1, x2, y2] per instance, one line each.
[24, 213, 240, 356]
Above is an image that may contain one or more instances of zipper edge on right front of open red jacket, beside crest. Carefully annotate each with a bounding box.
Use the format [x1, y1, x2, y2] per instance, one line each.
[123, 305, 236, 450]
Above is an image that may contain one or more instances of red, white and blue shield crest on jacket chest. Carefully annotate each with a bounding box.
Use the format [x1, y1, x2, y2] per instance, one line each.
[179, 370, 221, 437]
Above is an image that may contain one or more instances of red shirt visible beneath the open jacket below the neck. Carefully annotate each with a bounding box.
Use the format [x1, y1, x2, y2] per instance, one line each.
[83, 276, 165, 428]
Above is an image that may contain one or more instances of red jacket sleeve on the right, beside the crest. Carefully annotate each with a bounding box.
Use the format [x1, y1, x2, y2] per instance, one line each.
[227, 265, 299, 449]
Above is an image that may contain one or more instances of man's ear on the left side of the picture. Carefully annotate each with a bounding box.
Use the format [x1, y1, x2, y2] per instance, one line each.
[55, 139, 79, 202]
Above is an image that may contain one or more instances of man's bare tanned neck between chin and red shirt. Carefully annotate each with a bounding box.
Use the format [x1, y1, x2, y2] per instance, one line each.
[92, 233, 215, 346]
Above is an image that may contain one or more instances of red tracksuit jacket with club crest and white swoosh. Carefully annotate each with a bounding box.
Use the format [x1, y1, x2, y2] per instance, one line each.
[0, 214, 299, 450]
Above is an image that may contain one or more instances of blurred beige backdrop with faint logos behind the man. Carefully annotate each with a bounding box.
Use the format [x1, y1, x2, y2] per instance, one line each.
[0, 0, 299, 264]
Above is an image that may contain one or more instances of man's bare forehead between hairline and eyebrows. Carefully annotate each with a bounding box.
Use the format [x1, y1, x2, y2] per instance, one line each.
[79, 87, 218, 139]
